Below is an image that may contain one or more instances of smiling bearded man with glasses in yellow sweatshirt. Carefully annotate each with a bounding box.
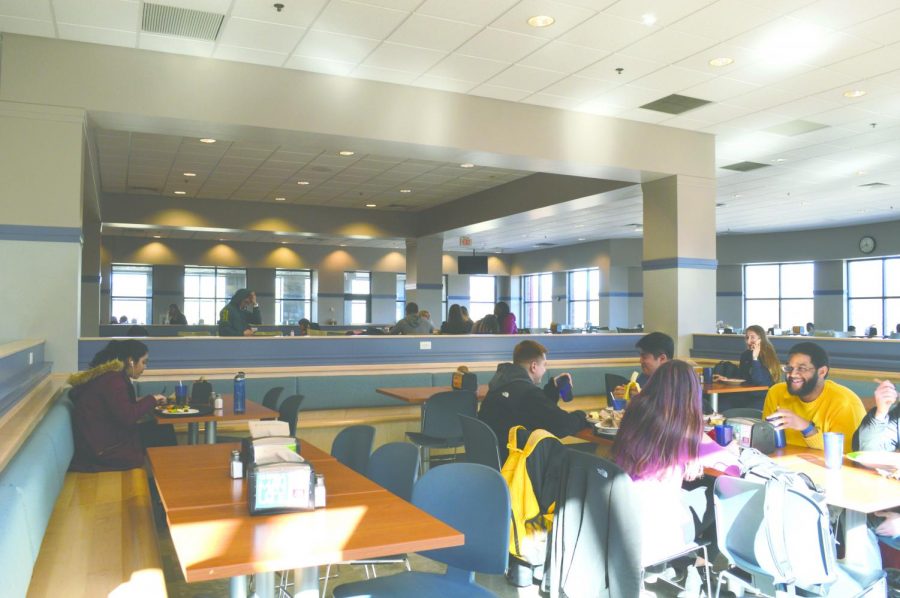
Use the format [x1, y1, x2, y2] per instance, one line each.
[763, 342, 866, 453]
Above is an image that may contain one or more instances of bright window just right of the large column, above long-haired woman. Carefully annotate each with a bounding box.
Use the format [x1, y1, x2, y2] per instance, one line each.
[744, 262, 815, 329]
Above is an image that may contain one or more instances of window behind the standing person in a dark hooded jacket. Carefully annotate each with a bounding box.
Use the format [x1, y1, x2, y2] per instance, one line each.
[184, 266, 247, 324]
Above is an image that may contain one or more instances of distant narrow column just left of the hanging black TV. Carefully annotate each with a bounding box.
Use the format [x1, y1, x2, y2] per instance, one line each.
[406, 235, 444, 322]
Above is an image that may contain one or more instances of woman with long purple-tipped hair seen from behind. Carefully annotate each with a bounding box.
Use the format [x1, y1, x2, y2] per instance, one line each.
[612, 359, 740, 596]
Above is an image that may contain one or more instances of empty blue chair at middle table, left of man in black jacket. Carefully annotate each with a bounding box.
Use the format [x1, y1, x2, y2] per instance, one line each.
[406, 390, 478, 469]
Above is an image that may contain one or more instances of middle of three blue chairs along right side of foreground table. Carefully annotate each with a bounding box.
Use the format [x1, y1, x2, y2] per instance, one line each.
[322, 442, 419, 596]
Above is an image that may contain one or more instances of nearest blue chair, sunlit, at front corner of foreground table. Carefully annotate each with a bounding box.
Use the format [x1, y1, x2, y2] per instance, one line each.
[334, 463, 510, 598]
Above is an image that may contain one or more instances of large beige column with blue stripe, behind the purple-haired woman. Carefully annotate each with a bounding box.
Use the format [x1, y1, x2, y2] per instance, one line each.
[641, 175, 716, 357]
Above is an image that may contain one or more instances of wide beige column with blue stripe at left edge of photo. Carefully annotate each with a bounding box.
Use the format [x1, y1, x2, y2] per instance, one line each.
[0, 102, 85, 372]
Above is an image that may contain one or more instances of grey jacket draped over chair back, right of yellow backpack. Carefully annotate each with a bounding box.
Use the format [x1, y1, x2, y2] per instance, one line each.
[544, 449, 641, 596]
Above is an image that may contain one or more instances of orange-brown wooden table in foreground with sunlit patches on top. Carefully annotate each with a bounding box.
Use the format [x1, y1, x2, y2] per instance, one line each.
[147, 441, 464, 598]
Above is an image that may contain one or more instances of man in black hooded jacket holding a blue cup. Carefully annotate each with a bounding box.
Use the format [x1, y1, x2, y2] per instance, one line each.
[478, 340, 588, 463]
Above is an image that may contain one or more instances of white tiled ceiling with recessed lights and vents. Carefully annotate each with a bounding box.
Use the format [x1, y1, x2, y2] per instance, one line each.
[0, 0, 900, 249]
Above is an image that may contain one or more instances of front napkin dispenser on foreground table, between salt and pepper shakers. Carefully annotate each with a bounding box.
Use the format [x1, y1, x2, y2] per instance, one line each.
[247, 462, 316, 515]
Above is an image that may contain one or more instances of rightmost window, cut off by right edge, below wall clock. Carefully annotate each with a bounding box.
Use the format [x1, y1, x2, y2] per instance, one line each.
[847, 257, 900, 335]
